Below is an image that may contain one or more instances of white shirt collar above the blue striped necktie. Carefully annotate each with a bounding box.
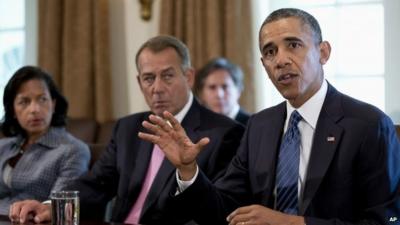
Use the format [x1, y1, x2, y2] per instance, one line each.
[286, 80, 328, 129]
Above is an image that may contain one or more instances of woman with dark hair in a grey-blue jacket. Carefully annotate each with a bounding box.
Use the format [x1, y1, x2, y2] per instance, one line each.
[0, 66, 90, 215]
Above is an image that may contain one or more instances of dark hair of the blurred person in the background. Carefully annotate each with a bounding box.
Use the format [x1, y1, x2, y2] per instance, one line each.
[194, 57, 243, 96]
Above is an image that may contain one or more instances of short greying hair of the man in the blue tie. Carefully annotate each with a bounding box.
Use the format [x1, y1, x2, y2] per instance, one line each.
[259, 8, 322, 49]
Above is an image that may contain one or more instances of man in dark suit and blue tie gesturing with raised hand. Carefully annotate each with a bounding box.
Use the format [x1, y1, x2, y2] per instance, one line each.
[139, 9, 400, 225]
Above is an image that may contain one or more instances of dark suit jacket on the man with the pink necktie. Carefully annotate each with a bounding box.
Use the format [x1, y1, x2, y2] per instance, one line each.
[70, 100, 244, 224]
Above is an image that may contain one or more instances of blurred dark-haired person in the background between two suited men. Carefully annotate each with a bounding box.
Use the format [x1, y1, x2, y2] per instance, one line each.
[194, 58, 250, 125]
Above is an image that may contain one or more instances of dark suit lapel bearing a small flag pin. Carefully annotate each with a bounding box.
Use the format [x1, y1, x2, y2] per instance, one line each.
[299, 85, 343, 215]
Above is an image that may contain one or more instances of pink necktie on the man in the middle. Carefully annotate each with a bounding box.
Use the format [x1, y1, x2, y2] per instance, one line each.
[124, 145, 164, 224]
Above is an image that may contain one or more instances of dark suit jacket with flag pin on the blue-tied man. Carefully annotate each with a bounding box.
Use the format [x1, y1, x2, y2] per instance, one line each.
[173, 85, 400, 225]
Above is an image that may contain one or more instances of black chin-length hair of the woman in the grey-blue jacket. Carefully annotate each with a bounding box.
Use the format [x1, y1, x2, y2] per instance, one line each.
[1, 66, 68, 137]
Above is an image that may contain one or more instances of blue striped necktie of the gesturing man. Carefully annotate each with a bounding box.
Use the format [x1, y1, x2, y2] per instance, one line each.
[276, 110, 301, 215]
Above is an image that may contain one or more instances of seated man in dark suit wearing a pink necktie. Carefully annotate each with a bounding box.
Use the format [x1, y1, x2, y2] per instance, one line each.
[10, 36, 244, 224]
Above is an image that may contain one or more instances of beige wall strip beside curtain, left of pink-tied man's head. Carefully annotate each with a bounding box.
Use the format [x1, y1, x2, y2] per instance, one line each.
[110, 0, 160, 118]
